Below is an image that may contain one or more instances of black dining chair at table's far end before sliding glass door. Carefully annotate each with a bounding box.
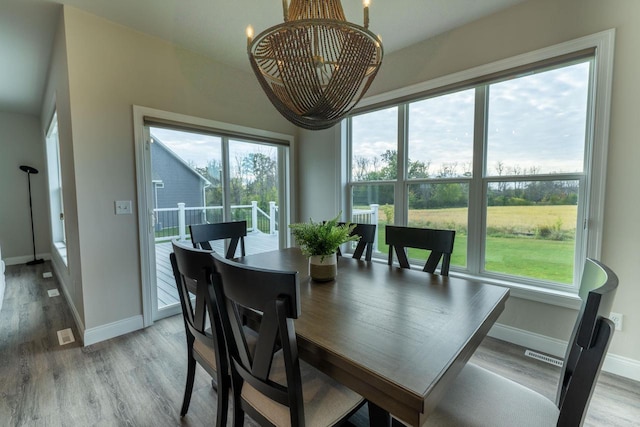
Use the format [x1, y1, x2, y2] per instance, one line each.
[189, 221, 247, 259]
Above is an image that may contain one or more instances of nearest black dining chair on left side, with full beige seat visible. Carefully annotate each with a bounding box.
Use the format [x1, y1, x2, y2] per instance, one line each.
[213, 254, 364, 427]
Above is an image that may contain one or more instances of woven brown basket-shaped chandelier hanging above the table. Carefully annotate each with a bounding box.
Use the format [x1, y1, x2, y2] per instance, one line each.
[247, 0, 382, 130]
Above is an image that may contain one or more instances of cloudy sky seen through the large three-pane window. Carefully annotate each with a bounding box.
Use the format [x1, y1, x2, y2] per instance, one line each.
[353, 62, 589, 174]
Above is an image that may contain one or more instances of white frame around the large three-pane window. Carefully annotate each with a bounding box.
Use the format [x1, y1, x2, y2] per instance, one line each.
[340, 29, 615, 308]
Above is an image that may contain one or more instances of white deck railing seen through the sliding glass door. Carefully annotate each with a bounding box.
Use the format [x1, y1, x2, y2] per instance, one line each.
[153, 201, 278, 242]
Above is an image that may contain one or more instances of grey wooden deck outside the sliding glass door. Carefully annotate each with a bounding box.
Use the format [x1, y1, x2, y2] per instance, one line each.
[156, 232, 278, 308]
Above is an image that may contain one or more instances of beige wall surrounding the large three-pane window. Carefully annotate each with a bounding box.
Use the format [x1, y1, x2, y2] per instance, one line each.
[300, 0, 640, 369]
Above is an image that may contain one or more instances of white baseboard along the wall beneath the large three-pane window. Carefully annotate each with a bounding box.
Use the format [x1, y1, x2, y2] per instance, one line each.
[488, 323, 640, 381]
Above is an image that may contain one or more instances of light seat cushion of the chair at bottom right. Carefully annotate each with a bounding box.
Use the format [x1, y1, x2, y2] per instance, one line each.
[426, 363, 560, 427]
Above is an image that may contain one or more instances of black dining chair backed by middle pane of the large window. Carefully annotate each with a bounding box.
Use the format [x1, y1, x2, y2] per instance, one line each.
[385, 225, 456, 276]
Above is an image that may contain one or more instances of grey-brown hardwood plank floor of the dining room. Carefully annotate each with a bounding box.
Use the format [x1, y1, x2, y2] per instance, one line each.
[0, 263, 640, 427]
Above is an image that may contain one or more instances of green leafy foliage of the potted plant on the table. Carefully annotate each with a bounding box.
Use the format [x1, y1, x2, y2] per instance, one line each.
[289, 215, 360, 258]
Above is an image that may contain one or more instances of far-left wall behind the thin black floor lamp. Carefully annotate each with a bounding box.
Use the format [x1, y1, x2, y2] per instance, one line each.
[0, 112, 51, 265]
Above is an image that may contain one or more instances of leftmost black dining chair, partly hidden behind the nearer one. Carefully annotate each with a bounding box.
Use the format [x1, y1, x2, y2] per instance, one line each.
[170, 240, 231, 427]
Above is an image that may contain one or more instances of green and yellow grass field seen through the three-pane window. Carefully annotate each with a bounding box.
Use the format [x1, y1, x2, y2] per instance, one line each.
[370, 206, 576, 284]
